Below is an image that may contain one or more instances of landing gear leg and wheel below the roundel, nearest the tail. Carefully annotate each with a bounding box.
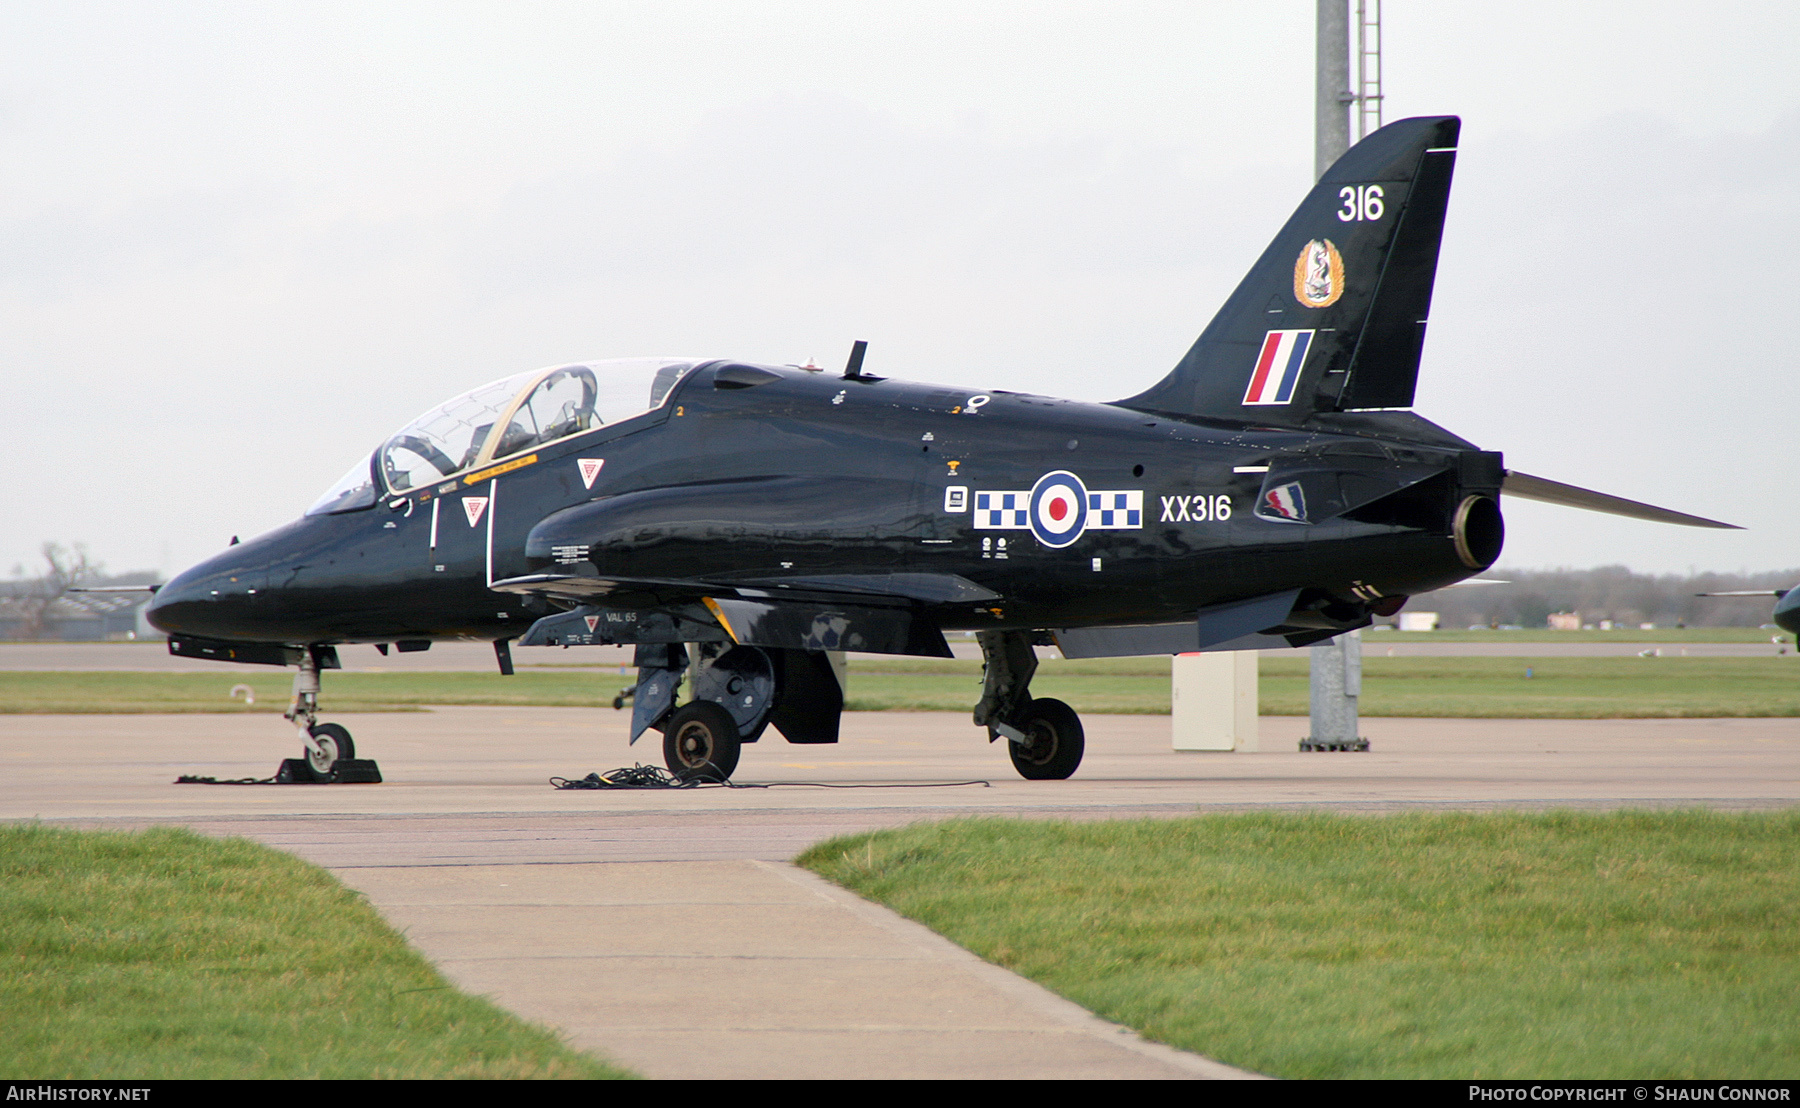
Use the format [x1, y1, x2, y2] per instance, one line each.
[976, 631, 1087, 781]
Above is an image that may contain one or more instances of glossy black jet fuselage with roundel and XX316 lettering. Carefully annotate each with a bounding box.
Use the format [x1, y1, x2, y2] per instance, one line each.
[149, 362, 1499, 644]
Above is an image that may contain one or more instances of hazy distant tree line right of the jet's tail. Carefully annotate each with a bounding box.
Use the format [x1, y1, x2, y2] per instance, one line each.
[1406, 565, 1800, 630]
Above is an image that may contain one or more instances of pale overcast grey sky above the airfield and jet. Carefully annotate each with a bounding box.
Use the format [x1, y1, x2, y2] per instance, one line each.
[0, 0, 1800, 572]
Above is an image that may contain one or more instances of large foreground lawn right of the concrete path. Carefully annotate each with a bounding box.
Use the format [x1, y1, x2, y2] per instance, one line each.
[799, 811, 1800, 1079]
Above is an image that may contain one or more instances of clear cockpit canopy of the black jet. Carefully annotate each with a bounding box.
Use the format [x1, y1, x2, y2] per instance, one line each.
[306, 358, 697, 516]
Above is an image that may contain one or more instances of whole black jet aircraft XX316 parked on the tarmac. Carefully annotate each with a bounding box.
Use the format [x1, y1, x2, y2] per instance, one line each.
[149, 117, 1726, 779]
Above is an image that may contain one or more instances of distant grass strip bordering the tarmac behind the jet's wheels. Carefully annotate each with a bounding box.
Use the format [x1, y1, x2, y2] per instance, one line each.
[0, 655, 1800, 719]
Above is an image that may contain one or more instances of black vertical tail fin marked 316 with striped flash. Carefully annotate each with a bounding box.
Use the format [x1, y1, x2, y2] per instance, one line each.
[1116, 115, 1462, 426]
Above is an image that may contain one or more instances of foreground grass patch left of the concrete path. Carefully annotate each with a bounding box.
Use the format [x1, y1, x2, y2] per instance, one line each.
[0, 824, 630, 1079]
